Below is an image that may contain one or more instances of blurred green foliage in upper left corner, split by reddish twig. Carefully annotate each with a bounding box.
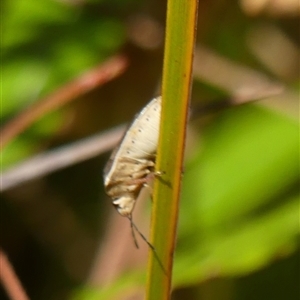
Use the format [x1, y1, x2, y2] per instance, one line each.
[1, 0, 125, 167]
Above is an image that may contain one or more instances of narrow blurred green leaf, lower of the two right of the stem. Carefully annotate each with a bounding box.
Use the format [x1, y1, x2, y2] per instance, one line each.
[174, 197, 300, 285]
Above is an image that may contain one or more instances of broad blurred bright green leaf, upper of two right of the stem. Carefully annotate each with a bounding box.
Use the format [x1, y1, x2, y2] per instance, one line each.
[185, 106, 299, 227]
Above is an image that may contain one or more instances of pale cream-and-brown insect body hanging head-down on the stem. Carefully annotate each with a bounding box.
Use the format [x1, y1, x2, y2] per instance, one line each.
[104, 97, 161, 220]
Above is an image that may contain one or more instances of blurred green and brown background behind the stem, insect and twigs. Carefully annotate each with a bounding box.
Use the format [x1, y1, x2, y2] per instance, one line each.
[0, 0, 300, 300]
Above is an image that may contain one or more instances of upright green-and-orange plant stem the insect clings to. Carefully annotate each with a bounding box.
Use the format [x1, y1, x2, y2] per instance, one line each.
[146, 0, 198, 300]
